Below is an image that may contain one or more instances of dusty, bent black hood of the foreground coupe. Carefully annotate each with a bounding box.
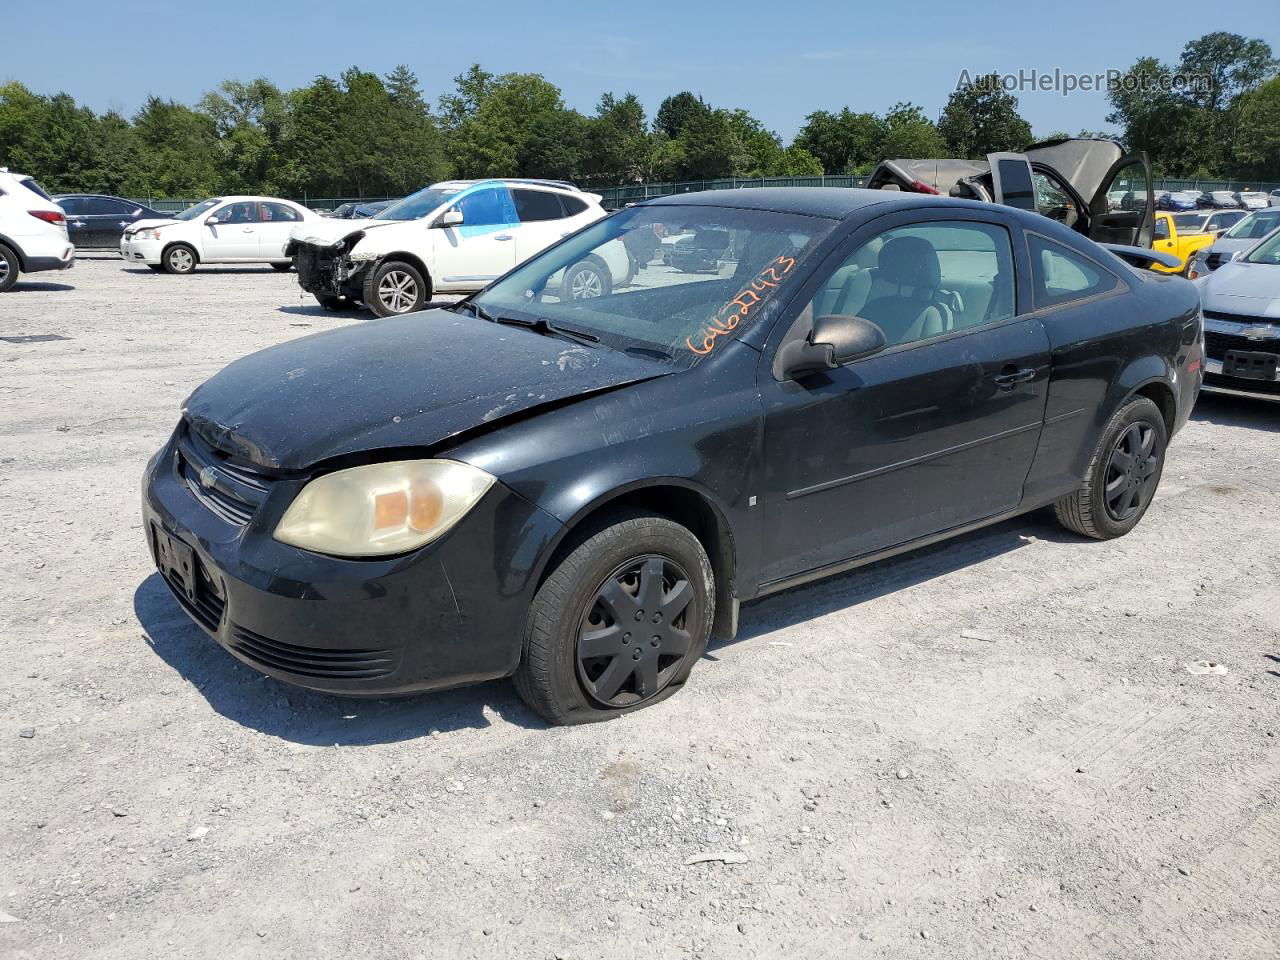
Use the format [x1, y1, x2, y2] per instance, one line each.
[184, 310, 672, 470]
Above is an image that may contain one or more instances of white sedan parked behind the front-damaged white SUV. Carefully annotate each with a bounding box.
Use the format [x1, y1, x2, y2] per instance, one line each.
[120, 197, 320, 274]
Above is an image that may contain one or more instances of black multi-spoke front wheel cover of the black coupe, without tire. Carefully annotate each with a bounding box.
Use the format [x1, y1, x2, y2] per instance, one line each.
[577, 554, 698, 708]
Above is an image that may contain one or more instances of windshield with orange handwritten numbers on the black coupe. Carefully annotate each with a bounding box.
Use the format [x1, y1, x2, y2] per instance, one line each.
[475, 205, 836, 366]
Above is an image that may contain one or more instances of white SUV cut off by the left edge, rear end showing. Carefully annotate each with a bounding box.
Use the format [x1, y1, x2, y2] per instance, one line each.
[0, 166, 76, 293]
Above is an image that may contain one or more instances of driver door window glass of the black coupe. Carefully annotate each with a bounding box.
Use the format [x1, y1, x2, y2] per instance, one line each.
[801, 220, 1015, 347]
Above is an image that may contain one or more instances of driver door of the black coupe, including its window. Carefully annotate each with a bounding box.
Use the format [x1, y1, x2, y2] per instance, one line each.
[759, 210, 1048, 585]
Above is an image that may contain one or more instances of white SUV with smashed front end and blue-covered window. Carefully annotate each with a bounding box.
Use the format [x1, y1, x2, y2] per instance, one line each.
[289, 179, 619, 316]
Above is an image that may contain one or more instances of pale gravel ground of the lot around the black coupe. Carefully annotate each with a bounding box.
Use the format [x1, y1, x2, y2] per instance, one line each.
[0, 257, 1280, 960]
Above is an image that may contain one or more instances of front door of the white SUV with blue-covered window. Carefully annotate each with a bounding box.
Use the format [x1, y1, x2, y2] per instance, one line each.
[431, 184, 520, 291]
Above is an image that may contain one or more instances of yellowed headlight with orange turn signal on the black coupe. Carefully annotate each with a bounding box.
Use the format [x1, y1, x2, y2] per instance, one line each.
[275, 460, 494, 557]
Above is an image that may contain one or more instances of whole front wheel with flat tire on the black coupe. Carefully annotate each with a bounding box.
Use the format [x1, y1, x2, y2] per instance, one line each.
[513, 515, 716, 724]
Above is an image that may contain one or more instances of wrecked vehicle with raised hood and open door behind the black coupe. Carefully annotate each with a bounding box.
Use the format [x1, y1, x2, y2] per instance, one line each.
[867, 140, 1156, 253]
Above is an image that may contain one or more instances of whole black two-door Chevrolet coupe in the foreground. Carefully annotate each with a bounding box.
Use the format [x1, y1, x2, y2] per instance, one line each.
[142, 188, 1203, 723]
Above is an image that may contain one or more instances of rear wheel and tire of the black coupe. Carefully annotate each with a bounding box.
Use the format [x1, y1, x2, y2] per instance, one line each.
[1053, 397, 1169, 540]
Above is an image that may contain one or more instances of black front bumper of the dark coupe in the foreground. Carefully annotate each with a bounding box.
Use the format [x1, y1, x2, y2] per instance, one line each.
[142, 428, 561, 695]
